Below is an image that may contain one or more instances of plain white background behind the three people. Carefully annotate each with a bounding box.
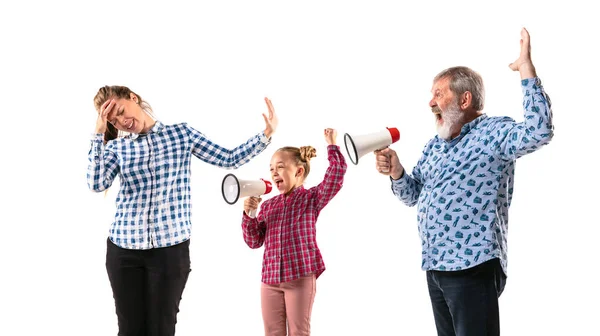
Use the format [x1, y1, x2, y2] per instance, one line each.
[0, 0, 600, 336]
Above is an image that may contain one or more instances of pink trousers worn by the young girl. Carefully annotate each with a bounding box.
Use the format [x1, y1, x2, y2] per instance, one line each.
[261, 274, 317, 336]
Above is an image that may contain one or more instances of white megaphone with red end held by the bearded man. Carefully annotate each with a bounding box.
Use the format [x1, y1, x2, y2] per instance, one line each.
[344, 127, 400, 165]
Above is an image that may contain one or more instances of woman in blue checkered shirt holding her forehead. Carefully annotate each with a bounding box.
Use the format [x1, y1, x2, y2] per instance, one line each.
[87, 86, 277, 336]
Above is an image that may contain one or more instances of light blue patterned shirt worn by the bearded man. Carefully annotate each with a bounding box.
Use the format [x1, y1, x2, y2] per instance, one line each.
[392, 77, 554, 273]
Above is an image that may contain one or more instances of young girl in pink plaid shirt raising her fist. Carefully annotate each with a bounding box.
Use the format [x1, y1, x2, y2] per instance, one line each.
[242, 128, 346, 336]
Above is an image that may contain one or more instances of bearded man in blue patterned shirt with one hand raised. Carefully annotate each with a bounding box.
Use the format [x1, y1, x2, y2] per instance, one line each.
[375, 28, 554, 336]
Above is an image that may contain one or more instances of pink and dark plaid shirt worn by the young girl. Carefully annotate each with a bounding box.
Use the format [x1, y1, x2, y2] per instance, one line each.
[242, 145, 346, 284]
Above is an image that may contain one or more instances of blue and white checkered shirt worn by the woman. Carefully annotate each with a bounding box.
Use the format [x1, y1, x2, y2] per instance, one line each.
[87, 121, 270, 249]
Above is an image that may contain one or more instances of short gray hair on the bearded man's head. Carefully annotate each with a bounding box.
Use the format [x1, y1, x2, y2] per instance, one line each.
[433, 66, 485, 111]
